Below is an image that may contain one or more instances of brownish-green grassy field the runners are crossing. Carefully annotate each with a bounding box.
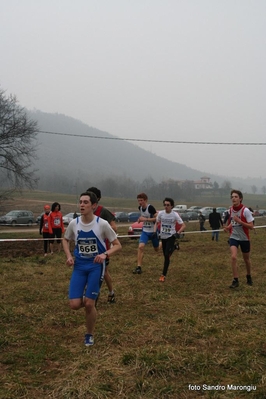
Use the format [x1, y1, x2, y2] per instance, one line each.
[0, 218, 266, 399]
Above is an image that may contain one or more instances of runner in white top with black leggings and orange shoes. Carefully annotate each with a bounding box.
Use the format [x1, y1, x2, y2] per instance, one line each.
[154, 197, 186, 282]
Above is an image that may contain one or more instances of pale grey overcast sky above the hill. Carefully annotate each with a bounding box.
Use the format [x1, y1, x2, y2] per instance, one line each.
[0, 0, 266, 178]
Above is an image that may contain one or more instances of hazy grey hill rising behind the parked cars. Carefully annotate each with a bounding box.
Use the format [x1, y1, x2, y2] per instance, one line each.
[28, 110, 262, 193]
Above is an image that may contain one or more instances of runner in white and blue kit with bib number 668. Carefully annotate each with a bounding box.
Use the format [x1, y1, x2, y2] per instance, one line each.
[63, 192, 121, 346]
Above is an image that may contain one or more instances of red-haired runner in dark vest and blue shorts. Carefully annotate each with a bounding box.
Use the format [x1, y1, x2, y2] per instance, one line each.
[133, 193, 159, 274]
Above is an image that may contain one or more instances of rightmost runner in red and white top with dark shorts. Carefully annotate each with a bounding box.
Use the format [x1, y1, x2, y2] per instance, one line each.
[224, 190, 254, 288]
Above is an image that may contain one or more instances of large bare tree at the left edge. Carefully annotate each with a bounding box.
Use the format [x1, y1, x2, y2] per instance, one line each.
[0, 89, 38, 198]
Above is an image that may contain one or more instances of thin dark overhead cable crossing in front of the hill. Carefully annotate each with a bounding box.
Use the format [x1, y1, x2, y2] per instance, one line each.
[38, 130, 266, 145]
